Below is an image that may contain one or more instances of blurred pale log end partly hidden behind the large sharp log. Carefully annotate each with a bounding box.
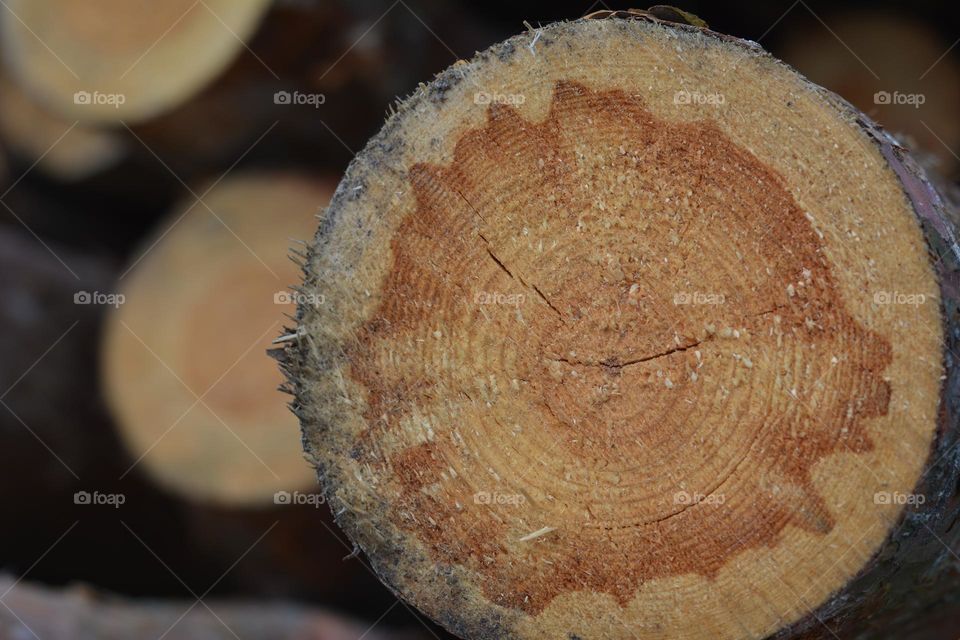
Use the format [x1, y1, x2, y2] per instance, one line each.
[102, 172, 332, 506]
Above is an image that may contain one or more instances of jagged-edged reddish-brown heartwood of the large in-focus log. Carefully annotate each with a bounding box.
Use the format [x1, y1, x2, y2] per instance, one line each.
[347, 83, 892, 614]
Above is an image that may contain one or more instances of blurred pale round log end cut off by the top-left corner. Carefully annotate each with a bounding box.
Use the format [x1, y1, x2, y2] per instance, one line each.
[0, 0, 270, 124]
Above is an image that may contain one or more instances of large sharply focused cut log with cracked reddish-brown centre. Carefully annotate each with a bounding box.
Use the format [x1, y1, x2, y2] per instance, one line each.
[279, 10, 960, 640]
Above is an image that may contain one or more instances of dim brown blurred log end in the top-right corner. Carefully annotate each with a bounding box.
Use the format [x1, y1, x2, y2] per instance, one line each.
[778, 8, 960, 178]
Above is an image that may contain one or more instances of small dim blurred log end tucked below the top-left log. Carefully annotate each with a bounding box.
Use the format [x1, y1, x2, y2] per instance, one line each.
[0, 74, 128, 182]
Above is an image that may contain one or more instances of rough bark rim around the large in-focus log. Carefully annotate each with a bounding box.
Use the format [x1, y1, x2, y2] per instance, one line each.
[273, 12, 960, 640]
